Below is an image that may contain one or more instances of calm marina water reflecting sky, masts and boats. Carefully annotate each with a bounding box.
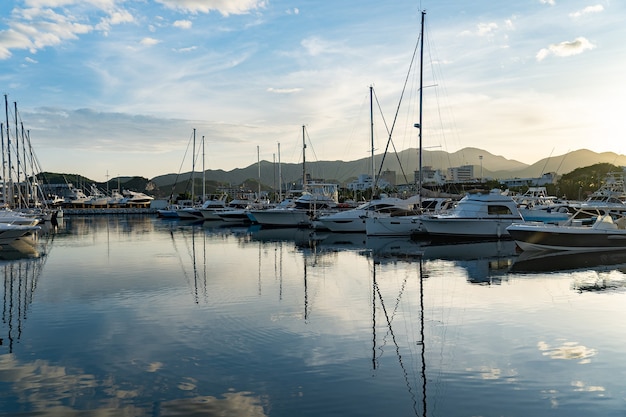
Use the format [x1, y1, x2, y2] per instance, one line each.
[0, 216, 626, 417]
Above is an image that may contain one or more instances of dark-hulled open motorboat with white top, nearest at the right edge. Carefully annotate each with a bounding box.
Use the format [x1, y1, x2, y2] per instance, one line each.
[507, 208, 626, 251]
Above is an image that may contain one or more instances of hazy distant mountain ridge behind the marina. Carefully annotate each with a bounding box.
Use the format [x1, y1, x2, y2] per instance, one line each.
[151, 147, 626, 187]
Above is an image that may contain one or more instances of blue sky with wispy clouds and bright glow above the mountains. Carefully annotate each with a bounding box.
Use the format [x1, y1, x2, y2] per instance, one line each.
[0, 0, 626, 181]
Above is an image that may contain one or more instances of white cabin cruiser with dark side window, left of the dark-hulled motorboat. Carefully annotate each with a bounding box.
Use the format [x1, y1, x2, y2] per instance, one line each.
[420, 189, 524, 238]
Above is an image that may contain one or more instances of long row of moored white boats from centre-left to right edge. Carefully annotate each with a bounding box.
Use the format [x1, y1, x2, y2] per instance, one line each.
[159, 167, 626, 258]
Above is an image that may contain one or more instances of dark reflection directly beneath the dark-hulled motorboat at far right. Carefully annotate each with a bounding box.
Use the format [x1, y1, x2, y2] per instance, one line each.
[511, 250, 626, 273]
